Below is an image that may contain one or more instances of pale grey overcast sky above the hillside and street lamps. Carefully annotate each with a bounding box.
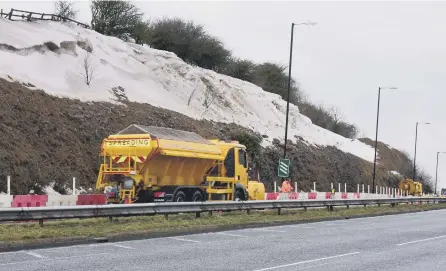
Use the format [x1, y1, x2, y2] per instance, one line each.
[0, 1, 446, 191]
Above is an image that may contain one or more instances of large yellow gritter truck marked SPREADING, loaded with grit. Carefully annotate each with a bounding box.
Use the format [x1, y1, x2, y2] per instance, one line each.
[96, 124, 265, 203]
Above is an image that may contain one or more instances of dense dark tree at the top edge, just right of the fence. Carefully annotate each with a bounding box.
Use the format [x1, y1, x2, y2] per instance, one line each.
[90, 0, 143, 38]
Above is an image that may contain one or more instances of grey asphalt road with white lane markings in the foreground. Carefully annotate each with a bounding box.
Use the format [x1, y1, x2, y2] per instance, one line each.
[0, 210, 446, 271]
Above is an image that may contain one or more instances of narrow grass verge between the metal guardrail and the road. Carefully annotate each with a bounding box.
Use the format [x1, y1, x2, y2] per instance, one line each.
[0, 203, 446, 250]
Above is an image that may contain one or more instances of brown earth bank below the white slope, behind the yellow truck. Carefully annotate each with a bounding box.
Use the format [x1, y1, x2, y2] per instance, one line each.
[0, 79, 412, 194]
